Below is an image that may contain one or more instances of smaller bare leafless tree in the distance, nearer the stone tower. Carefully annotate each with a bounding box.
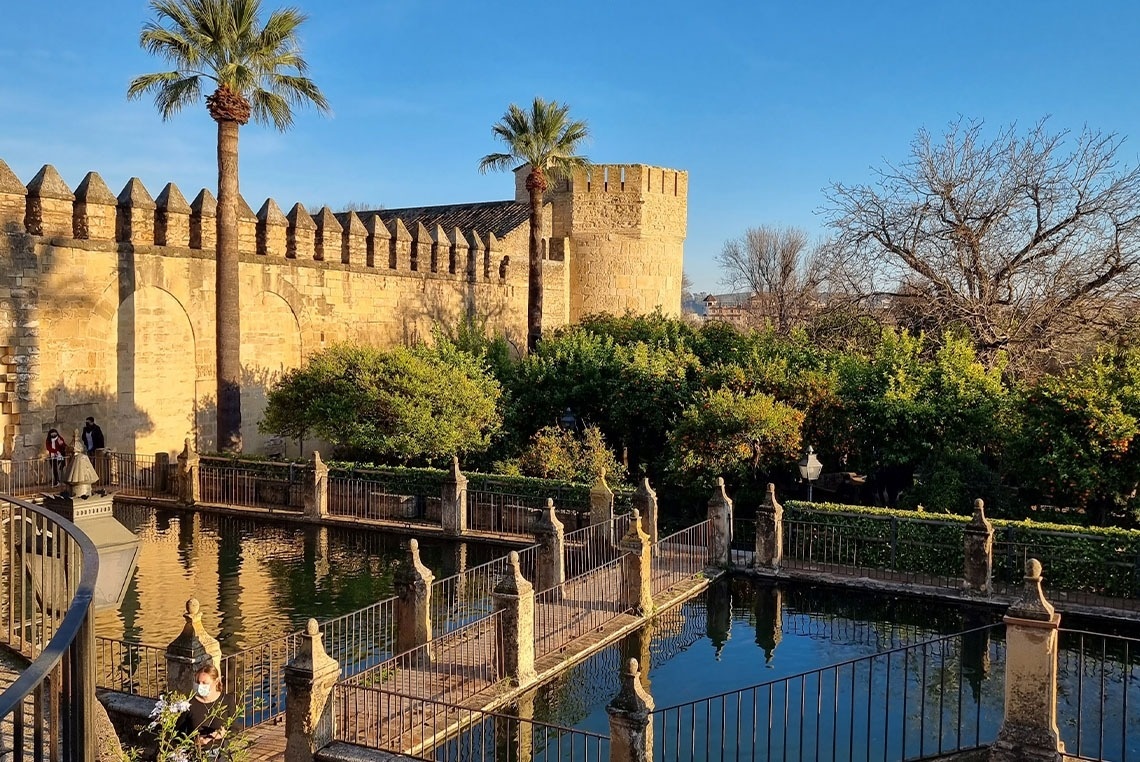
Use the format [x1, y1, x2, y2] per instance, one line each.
[717, 225, 824, 334]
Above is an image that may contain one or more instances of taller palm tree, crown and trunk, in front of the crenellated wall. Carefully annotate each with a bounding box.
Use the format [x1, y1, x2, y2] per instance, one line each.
[127, 0, 328, 452]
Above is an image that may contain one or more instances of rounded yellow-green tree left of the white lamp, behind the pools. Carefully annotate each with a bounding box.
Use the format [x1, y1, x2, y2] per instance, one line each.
[669, 389, 804, 486]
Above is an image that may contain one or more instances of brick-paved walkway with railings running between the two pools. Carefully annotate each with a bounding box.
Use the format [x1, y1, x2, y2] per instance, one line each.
[250, 538, 717, 760]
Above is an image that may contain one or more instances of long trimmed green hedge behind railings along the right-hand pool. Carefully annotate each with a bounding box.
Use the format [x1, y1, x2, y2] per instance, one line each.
[784, 501, 1140, 598]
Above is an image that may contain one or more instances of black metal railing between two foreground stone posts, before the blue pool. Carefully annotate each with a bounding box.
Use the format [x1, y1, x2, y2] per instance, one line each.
[652, 625, 1004, 761]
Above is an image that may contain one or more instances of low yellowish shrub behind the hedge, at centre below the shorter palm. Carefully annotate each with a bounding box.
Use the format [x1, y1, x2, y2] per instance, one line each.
[518, 425, 626, 484]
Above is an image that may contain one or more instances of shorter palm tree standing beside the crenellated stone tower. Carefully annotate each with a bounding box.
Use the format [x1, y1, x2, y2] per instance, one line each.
[479, 98, 589, 351]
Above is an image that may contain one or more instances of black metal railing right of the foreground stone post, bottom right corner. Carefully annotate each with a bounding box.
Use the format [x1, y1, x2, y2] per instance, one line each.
[1057, 629, 1140, 761]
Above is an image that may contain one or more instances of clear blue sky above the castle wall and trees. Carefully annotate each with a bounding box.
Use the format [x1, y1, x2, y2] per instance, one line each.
[0, 0, 1140, 291]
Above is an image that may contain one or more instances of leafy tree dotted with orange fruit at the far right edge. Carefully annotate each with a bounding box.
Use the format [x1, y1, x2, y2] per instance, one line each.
[1007, 349, 1140, 524]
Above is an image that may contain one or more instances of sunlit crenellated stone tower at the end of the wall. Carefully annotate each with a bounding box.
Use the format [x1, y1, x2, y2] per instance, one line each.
[516, 164, 689, 323]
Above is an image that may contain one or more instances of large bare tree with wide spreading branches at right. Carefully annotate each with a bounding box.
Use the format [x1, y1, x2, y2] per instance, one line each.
[825, 120, 1140, 367]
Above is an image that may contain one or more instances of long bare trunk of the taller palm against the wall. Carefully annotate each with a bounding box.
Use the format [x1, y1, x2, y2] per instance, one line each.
[214, 120, 242, 453]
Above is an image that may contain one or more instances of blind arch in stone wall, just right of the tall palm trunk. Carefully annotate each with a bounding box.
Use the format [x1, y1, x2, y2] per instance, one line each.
[242, 291, 301, 454]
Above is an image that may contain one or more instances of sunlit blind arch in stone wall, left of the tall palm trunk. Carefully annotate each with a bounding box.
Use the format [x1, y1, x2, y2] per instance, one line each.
[101, 286, 197, 454]
